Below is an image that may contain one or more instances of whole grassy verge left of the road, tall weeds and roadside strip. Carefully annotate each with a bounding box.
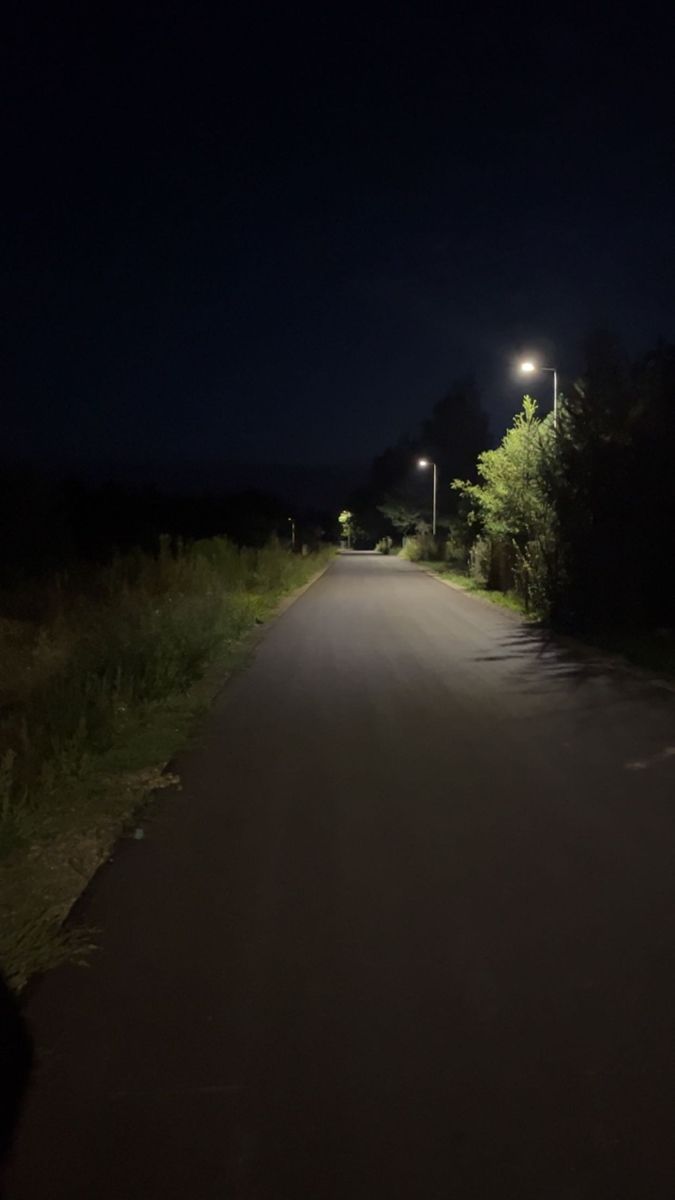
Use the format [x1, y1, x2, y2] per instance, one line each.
[0, 539, 331, 988]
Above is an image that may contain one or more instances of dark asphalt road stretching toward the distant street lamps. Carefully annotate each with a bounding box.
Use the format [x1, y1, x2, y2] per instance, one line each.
[10, 554, 675, 1200]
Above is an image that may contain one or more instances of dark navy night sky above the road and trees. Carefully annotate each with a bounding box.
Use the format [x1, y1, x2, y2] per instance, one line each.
[2, 2, 675, 463]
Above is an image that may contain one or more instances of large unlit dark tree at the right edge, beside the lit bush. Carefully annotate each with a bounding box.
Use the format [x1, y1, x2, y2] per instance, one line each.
[550, 332, 675, 632]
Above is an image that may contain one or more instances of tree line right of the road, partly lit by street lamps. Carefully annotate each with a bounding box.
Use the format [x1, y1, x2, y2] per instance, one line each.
[350, 332, 675, 631]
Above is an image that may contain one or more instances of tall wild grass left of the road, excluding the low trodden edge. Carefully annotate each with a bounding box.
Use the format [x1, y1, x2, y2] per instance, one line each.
[0, 538, 330, 857]
